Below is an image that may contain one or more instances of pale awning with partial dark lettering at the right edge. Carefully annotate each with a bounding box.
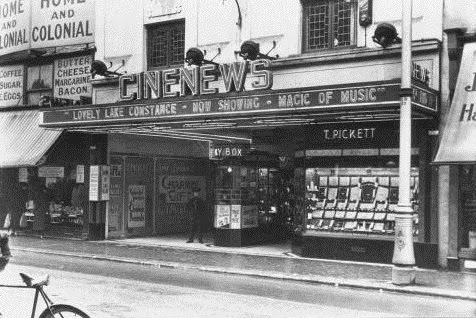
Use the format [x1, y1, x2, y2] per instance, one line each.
[434, 43, 476, 164]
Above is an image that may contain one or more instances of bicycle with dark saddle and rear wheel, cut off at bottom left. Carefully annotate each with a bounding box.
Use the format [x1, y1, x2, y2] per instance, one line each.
[0, 233, 90, 318]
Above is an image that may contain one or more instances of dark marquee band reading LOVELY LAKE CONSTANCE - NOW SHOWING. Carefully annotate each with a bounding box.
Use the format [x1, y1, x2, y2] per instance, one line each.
[42, 82, 437, 127]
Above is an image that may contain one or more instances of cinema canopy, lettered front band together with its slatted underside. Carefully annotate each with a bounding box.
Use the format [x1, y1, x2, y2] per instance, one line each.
[40, 81, 438, 142]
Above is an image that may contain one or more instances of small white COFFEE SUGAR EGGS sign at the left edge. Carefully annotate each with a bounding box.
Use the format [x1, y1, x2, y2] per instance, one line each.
[0, 64, 23, 108]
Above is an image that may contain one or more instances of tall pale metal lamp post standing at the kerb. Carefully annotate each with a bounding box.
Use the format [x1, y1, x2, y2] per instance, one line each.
[392, 0, 415, 285]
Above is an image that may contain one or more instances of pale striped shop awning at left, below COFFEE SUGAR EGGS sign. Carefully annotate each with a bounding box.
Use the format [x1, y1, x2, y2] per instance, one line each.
[0, 110, 61, 168]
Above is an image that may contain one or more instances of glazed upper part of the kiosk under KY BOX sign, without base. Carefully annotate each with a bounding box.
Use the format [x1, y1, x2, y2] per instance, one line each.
[215, 166, 295, 236]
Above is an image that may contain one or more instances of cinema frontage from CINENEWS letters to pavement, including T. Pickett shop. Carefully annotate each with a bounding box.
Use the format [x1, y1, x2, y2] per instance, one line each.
[41, 41, 439, 266]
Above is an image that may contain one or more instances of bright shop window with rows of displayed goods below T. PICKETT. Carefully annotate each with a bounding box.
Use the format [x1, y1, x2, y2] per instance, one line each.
[305, 168, 419, 236]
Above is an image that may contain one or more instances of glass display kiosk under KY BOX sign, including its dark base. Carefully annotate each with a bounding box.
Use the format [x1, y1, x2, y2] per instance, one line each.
[214, 162, 295, 246]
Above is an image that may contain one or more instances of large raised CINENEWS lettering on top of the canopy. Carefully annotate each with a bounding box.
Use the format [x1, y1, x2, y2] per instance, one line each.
[119, 60, 273, 100]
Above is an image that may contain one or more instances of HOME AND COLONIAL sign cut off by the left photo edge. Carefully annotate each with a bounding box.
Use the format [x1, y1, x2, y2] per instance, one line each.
[0, 0, 31, 56]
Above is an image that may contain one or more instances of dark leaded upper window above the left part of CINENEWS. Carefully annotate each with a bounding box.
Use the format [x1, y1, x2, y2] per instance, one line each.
[147, 20, 185, 69]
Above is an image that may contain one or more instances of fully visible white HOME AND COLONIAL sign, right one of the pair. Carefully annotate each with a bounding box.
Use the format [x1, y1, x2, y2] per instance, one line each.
[31, 0, 95, 48]
